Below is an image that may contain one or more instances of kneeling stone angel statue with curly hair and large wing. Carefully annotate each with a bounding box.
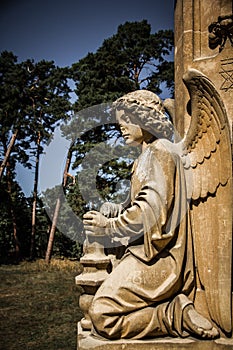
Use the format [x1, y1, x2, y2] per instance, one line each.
[83, 69, 232, 339]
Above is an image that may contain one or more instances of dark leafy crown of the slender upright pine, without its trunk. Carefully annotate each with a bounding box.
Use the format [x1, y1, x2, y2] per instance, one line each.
[22, 60, 71, 142]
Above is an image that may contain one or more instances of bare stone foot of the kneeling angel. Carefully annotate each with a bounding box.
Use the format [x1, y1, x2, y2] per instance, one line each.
[183, 305, 219, 339]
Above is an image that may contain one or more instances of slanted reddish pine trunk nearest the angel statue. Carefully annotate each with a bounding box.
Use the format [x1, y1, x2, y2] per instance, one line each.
[45, 142, 74, 264]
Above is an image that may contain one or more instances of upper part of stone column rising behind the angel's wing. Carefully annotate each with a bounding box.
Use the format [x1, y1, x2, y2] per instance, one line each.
[175, 0, 233, 136]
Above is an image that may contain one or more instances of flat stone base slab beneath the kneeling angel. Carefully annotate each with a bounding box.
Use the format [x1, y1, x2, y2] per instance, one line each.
[77, 323, 233, 350]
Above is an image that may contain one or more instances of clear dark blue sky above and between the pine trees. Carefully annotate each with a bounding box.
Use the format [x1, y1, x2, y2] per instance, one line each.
[0, 0, 174, 195]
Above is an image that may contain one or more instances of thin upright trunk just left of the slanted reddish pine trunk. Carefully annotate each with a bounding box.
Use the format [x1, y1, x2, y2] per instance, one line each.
[30, 132, 41, 260]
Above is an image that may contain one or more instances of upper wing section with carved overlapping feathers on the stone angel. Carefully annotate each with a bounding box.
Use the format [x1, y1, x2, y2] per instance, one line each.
[178, 69, 231, 200]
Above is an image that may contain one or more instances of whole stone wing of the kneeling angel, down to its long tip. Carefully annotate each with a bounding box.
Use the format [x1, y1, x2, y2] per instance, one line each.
[176, 69, 232, 333]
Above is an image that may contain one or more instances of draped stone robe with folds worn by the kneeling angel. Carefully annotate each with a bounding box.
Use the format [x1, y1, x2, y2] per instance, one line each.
[89, 140, 195, 339]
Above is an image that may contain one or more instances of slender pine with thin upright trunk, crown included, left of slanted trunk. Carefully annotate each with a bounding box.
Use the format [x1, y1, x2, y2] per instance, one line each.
[20, 60, 71, 259]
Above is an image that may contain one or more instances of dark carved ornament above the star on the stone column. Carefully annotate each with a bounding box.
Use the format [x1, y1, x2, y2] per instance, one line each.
[208, 14, 233, 52]
